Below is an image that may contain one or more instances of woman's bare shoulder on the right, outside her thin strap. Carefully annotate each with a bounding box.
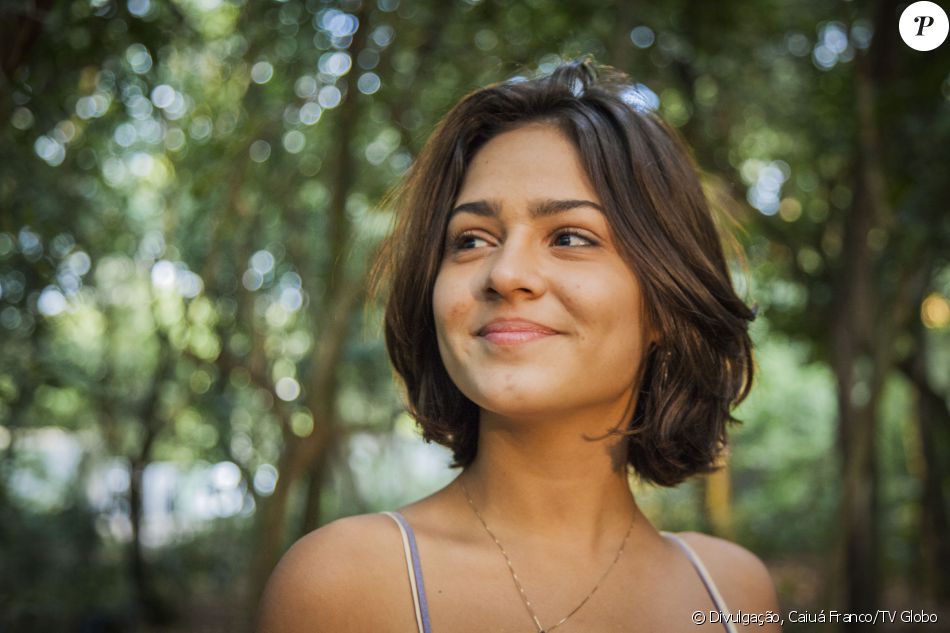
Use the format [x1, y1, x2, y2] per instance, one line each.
[679, 532, 780, 631]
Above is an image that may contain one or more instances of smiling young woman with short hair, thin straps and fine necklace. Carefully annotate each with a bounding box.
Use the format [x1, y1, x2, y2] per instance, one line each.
[259, 62, 779, 633]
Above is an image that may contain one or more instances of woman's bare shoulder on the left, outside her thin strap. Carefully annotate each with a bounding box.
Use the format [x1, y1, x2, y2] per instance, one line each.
[257, 514, 405, 633]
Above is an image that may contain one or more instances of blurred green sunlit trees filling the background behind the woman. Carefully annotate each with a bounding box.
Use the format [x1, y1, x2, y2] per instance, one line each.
[0, 0, 950, 633]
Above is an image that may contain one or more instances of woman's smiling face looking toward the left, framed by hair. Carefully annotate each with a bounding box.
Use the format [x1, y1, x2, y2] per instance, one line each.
[433, 124, 645, 422]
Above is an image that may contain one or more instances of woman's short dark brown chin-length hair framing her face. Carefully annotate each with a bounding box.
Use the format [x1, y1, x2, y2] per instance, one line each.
[377, 61, 754, 486]
